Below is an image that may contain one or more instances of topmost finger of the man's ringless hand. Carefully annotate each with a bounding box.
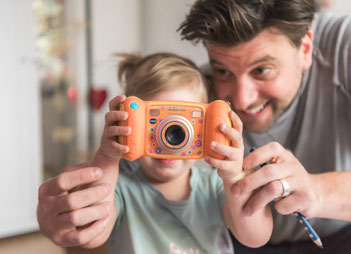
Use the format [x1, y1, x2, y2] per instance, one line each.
[43, 167, 103, 196]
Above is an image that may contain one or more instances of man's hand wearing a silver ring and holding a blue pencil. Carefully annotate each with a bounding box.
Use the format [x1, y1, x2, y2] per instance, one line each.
[232, 142, 321, 218]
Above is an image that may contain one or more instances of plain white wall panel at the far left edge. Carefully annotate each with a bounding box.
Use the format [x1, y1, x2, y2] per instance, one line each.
[0, 0, 42, 238]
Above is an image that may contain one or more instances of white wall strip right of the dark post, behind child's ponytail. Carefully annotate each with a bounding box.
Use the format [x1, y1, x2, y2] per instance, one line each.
[91, 0, 142, 150]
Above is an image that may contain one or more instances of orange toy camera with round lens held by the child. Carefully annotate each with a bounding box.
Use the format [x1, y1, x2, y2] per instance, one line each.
[119, 96, 231, 160]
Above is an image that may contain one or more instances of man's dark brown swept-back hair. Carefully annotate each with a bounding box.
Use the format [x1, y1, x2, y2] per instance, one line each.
[178, 0, 315, 47]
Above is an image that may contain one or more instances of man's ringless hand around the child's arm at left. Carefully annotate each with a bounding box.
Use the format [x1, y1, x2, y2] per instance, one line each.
[37, 164, 115, 247]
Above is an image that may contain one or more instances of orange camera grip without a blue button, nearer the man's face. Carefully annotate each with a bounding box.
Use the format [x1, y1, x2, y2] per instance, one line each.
[204, 100, 232, 159]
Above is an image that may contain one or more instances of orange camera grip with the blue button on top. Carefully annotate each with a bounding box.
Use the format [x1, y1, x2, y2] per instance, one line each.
[118, 96, 146, 160]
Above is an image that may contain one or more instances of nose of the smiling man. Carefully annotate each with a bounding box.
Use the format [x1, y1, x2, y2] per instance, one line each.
[231, 79, 258, 110]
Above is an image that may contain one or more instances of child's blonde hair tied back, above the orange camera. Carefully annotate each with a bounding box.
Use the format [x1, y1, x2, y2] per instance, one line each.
[116, 53, 208, 102]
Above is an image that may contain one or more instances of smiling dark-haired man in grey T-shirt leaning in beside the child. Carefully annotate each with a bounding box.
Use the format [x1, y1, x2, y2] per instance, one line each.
[179, 0, 351, 253]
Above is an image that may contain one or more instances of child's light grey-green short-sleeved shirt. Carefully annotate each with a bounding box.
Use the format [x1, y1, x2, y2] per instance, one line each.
[109, 160, 233, 254]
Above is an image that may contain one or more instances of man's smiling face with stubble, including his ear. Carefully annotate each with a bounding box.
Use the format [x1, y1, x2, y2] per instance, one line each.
[206, 30, 312, 132]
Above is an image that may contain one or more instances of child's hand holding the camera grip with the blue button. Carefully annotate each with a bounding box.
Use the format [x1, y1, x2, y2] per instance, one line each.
[99, 95, 131, 161]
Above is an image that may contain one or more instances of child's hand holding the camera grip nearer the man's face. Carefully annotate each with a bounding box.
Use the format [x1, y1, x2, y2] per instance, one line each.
[205, 111, 244, 185]
